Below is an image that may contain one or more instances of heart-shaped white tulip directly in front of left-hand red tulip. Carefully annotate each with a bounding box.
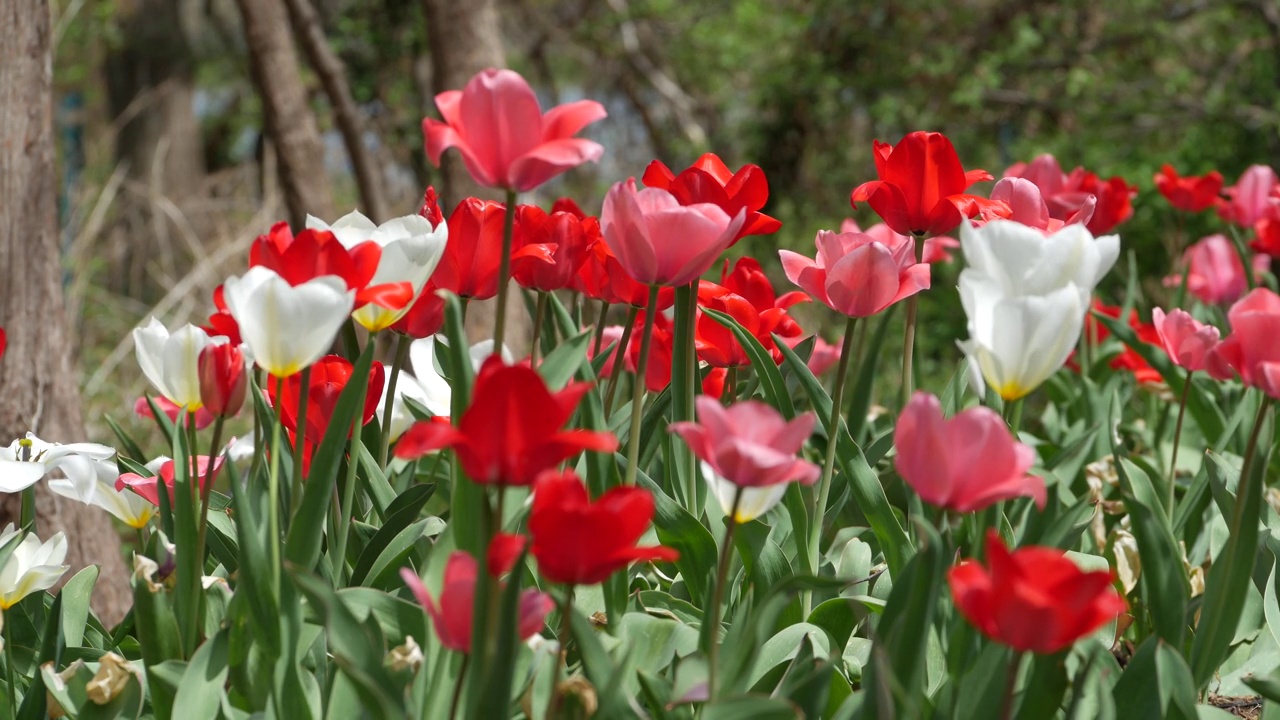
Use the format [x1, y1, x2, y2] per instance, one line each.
[222, 266, 355, 376]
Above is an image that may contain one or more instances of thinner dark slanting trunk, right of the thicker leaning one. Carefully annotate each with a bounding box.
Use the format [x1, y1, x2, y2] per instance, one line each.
[285, 0, 388, 223]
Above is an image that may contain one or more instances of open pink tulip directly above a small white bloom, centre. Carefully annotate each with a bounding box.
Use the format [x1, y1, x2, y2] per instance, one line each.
[671, 395, 819, 488]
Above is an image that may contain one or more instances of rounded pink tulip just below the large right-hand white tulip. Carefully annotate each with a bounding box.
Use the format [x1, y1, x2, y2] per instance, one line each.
[893, 392, 1046, 512]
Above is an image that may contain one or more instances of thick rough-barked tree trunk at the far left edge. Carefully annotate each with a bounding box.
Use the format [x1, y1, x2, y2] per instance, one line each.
[0, 0, 129, 624]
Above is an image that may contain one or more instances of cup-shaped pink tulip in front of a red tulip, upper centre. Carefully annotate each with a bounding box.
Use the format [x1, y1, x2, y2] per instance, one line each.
[600, 178, 746, 287]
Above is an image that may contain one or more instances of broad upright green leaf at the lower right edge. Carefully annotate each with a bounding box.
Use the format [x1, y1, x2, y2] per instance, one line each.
[1187, 401, 1272, 688]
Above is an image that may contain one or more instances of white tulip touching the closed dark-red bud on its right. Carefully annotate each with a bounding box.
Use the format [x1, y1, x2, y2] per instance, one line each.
[133, 318, 227, 410]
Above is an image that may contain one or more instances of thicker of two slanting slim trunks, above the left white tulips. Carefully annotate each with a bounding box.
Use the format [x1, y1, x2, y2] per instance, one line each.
[236, 0, 334, 228]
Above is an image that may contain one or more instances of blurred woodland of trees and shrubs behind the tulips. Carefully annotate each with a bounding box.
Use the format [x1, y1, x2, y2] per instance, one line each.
[51, 0, 1280, 425]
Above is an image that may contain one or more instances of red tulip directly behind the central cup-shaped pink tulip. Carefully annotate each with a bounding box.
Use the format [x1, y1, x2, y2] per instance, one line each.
[641, 152, 782, 242]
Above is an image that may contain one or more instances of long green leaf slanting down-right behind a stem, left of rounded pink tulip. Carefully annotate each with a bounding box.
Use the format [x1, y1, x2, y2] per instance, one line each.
[778, 333, 911, 573]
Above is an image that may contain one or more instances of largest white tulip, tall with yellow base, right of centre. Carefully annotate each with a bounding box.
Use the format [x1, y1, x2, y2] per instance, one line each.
[960, 220, 1120, 401]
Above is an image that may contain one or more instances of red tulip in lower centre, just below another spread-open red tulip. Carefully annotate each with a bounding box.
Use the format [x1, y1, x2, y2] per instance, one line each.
[529, 470, 680, 585]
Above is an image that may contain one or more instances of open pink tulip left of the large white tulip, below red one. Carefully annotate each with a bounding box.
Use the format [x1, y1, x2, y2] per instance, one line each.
[778, 231, 929, 318]
